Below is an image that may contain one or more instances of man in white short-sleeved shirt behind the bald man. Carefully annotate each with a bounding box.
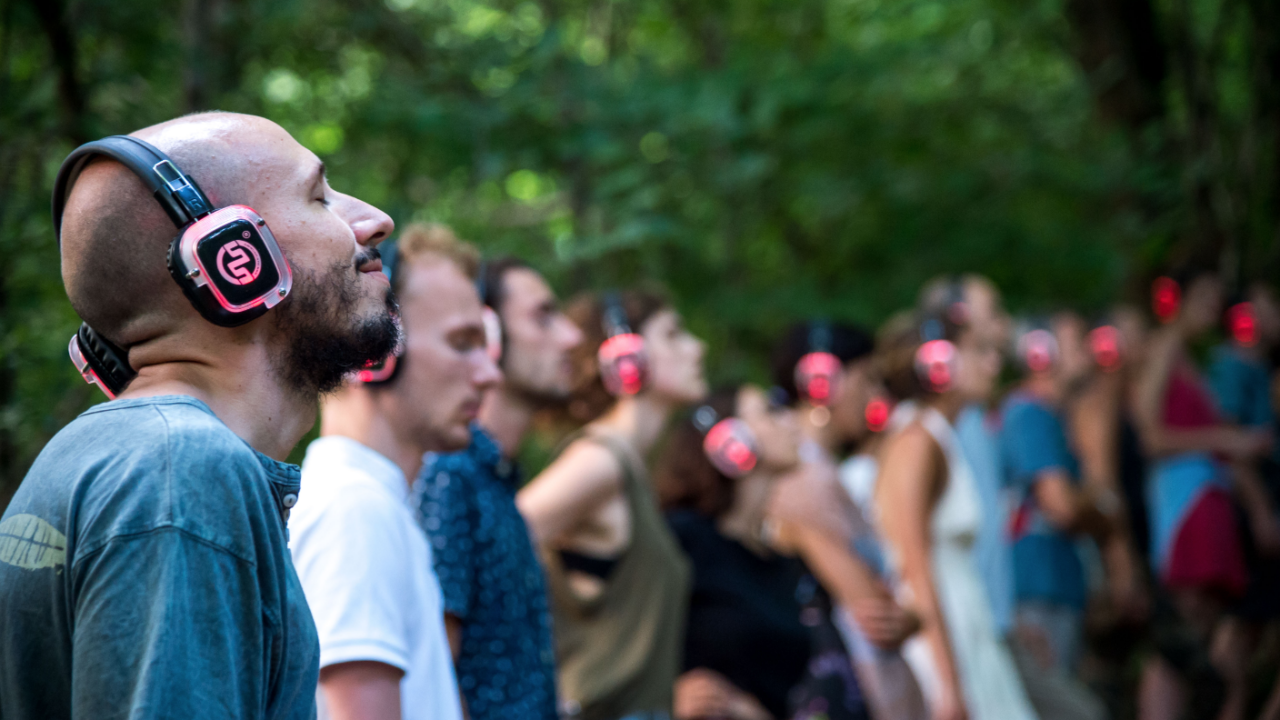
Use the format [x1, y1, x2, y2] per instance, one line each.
[292, 225, 500, 720]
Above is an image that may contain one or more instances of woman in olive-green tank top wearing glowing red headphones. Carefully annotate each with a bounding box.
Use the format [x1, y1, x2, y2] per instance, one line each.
[516, 291, 707, 720]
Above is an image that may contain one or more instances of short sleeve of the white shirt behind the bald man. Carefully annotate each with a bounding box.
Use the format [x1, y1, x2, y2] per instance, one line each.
[292, 491, 420, 671]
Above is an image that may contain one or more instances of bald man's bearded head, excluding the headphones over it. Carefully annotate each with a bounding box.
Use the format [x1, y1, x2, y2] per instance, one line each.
[61, 113, 397, 389]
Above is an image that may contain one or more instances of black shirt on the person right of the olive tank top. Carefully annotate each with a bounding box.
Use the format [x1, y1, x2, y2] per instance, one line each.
[667, 510, 812, 717]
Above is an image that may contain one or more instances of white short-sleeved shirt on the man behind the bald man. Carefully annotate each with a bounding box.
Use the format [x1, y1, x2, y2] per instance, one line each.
[289, 436, 462, 720]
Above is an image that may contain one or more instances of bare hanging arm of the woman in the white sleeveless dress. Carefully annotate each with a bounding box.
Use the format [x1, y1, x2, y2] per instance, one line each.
[876, 424, 963, 712]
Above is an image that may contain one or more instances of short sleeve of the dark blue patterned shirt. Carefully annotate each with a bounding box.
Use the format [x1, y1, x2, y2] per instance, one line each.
[421, 456, 477, 620]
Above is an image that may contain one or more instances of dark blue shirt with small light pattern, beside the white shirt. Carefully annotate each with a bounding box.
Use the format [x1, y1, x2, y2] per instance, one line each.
[415, 427, 557, 720]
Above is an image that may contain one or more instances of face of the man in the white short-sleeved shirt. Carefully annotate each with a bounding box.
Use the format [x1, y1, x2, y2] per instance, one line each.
[388, 258, 502, 451]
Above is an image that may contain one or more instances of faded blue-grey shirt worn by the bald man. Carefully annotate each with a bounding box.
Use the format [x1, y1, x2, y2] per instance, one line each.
[0, 396, 320, 720]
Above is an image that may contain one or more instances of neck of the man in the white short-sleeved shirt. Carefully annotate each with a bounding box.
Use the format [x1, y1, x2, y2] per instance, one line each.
[320, 387, 430, 483]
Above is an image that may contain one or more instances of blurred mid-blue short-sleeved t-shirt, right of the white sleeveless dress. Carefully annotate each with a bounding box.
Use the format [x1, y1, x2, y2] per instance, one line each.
[1000, 393, 1085, 610]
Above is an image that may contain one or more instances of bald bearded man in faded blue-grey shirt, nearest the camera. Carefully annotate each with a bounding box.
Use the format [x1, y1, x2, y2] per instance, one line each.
[0, 113, 399, 720]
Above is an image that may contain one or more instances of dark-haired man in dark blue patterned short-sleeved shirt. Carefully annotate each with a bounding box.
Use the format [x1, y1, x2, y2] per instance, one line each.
[415, 258, 582, 720]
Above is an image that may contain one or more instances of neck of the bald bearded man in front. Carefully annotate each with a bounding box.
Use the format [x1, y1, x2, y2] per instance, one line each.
[120, 337, 316, 460]
